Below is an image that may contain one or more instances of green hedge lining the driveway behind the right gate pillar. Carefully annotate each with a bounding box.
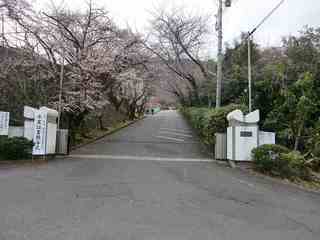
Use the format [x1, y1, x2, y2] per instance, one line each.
[181, 104, 246, 146]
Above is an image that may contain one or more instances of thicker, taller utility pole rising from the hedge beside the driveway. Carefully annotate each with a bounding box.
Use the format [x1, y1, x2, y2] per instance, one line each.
[216, 0, 223, 108]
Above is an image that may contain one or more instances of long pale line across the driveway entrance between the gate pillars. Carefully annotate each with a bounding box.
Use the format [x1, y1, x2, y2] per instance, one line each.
[68, 154, 214, 162]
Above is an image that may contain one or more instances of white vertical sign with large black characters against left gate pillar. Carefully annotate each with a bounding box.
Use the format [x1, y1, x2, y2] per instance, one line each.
[32, 111, 47, 155]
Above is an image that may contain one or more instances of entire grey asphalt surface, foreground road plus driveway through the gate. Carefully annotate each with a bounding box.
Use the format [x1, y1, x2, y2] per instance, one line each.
[0, 112, 320, 240]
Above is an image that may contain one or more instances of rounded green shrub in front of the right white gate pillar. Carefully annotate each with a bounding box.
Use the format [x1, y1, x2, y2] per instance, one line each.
[252, 144, 310, 180]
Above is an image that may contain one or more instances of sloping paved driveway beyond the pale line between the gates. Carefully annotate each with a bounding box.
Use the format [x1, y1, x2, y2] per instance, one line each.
[73, 111, 209, 159]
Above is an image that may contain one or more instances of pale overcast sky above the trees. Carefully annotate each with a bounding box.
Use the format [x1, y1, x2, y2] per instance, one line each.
[35, 0, 320, 52]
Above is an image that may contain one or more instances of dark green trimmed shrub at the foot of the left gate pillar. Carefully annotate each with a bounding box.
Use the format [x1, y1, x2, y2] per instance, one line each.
[0, 137, 33, 160]
